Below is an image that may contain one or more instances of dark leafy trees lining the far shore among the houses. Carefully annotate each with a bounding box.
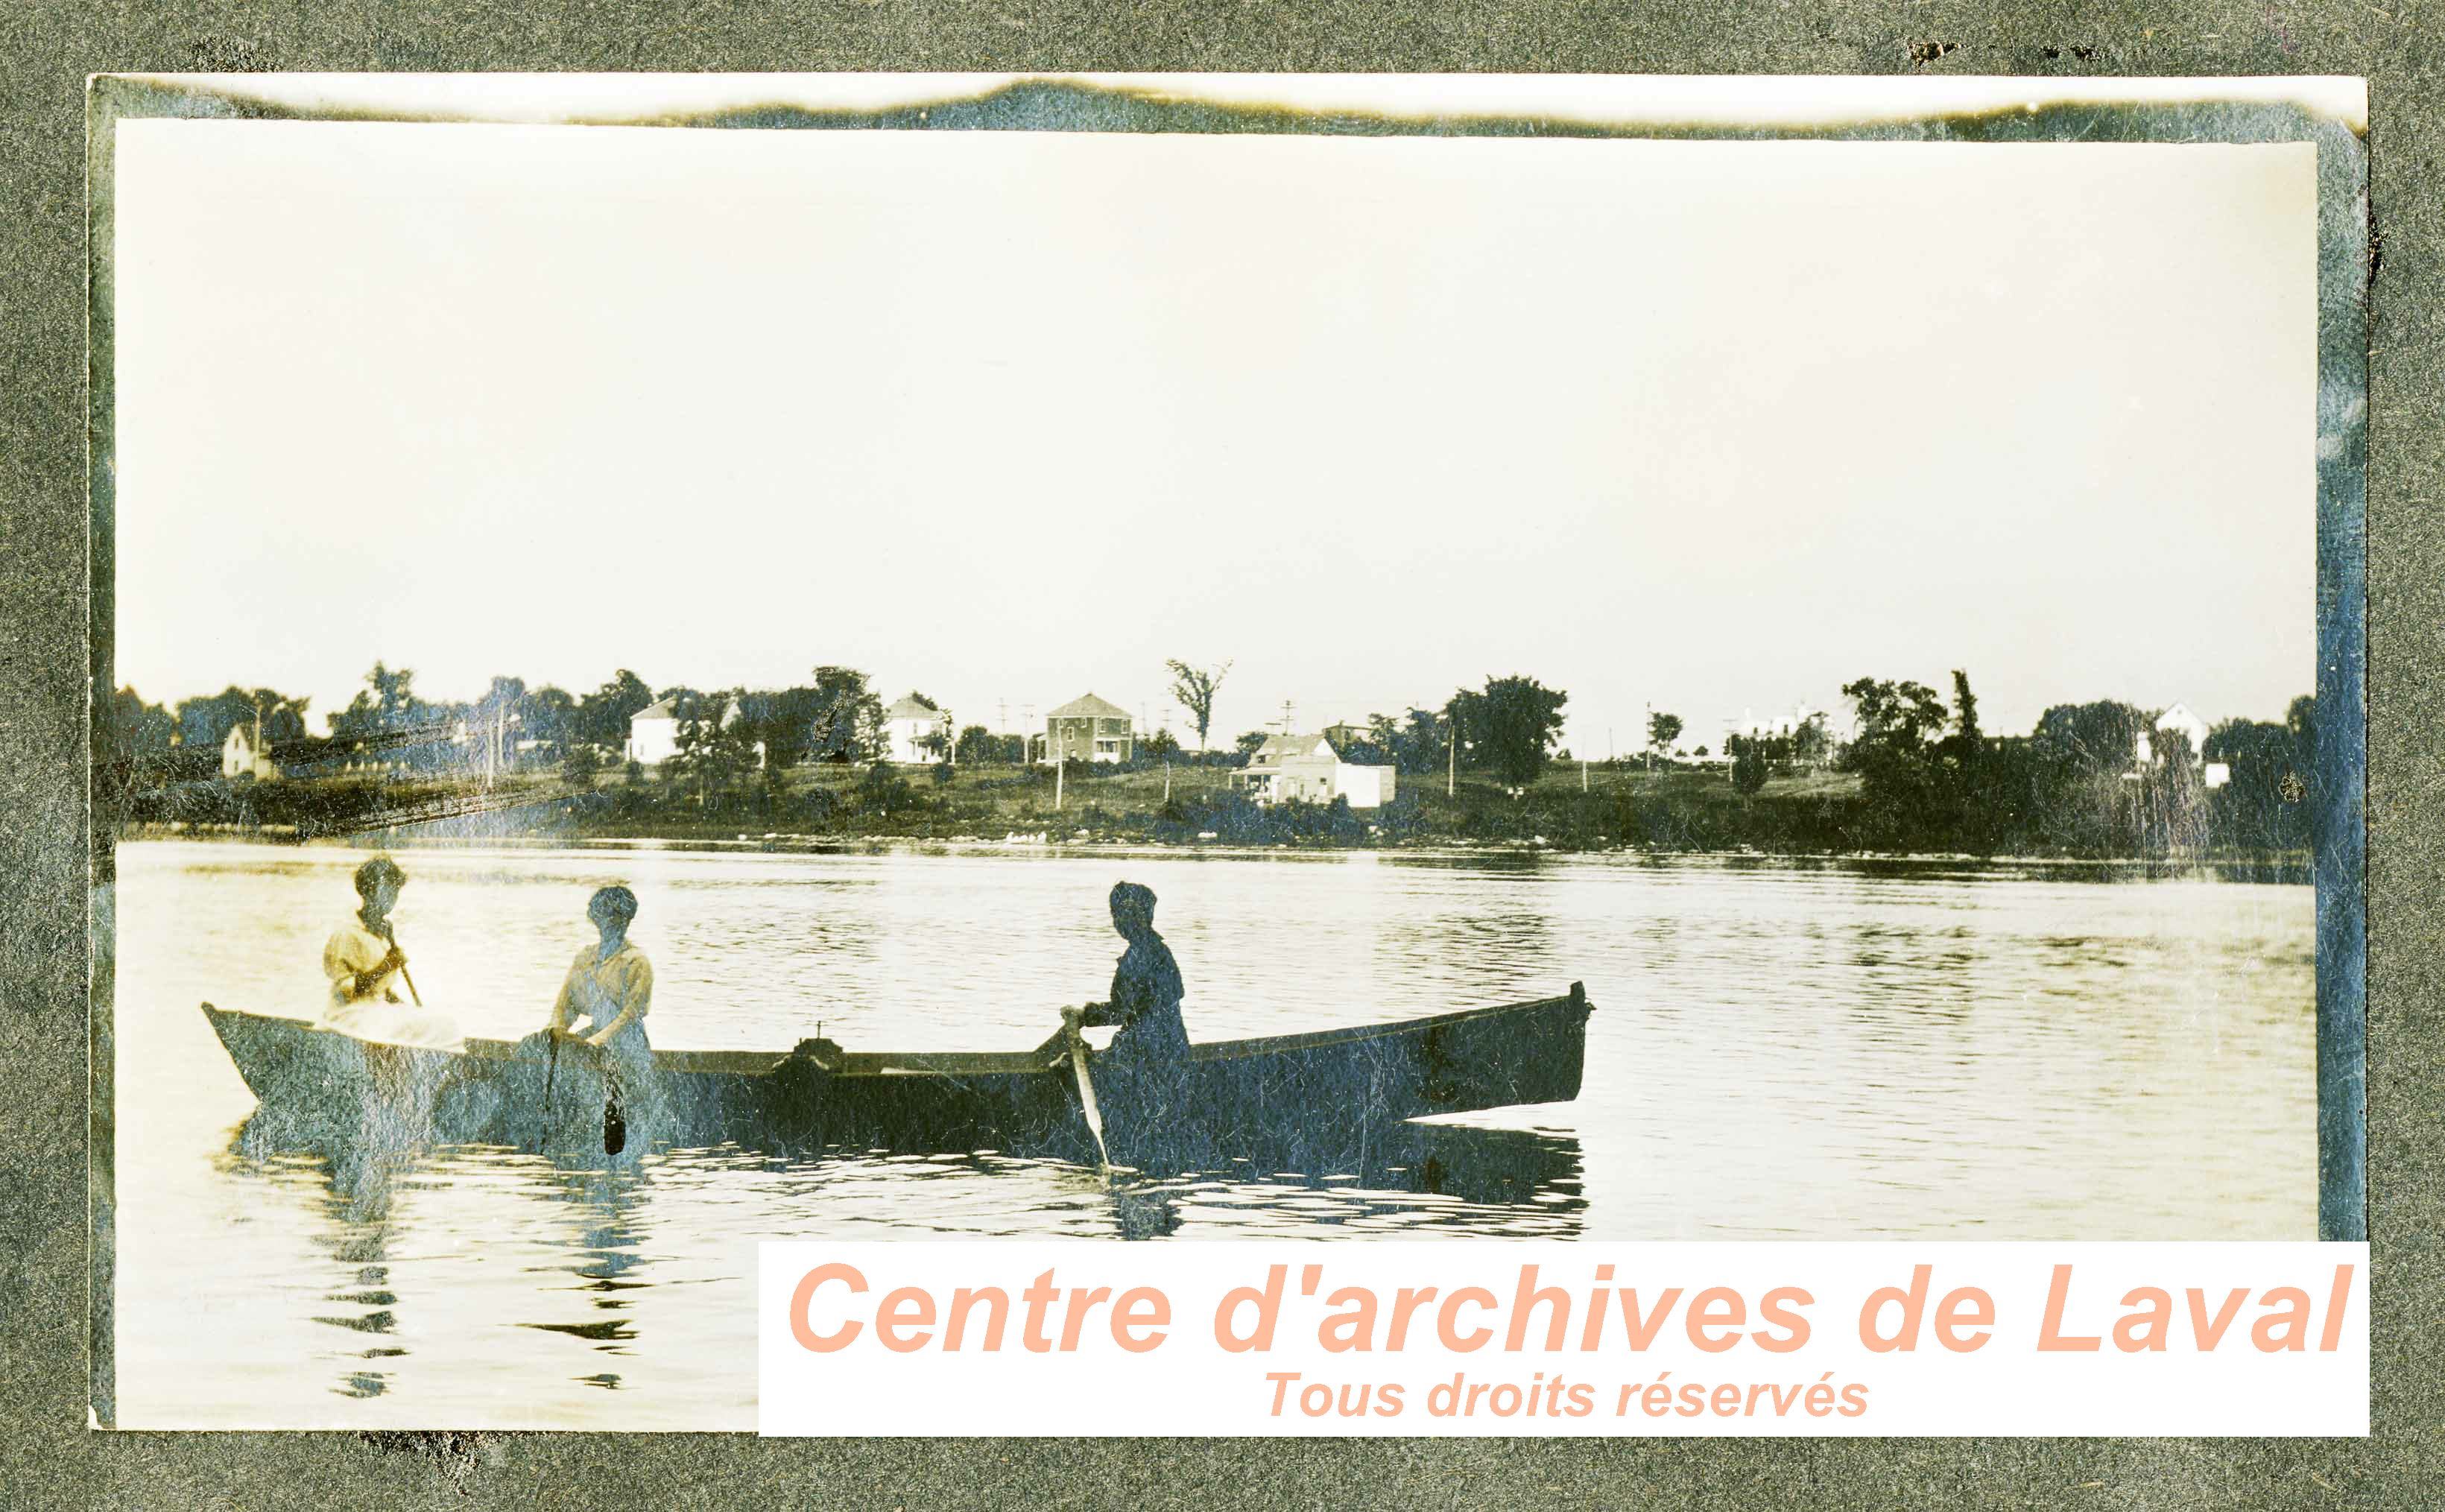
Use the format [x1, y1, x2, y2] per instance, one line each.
[95, 660, 2321, 856]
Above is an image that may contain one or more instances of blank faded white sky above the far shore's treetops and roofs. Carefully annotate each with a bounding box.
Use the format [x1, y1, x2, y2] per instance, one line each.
[117, 122, 2315, 753]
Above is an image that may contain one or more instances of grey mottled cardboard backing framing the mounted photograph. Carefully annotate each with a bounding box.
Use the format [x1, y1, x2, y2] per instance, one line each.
[0, 0, 2445, 1507]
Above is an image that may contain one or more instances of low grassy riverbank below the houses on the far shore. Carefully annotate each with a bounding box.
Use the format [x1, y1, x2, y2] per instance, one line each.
[110, 763, 2306, 876]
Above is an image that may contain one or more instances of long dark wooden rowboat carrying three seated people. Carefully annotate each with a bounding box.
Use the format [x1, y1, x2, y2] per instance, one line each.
[203, 984, 1592, 1169]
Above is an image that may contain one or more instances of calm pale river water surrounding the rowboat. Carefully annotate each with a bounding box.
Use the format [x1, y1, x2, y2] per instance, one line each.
[115, 841, 2318, 1429]
